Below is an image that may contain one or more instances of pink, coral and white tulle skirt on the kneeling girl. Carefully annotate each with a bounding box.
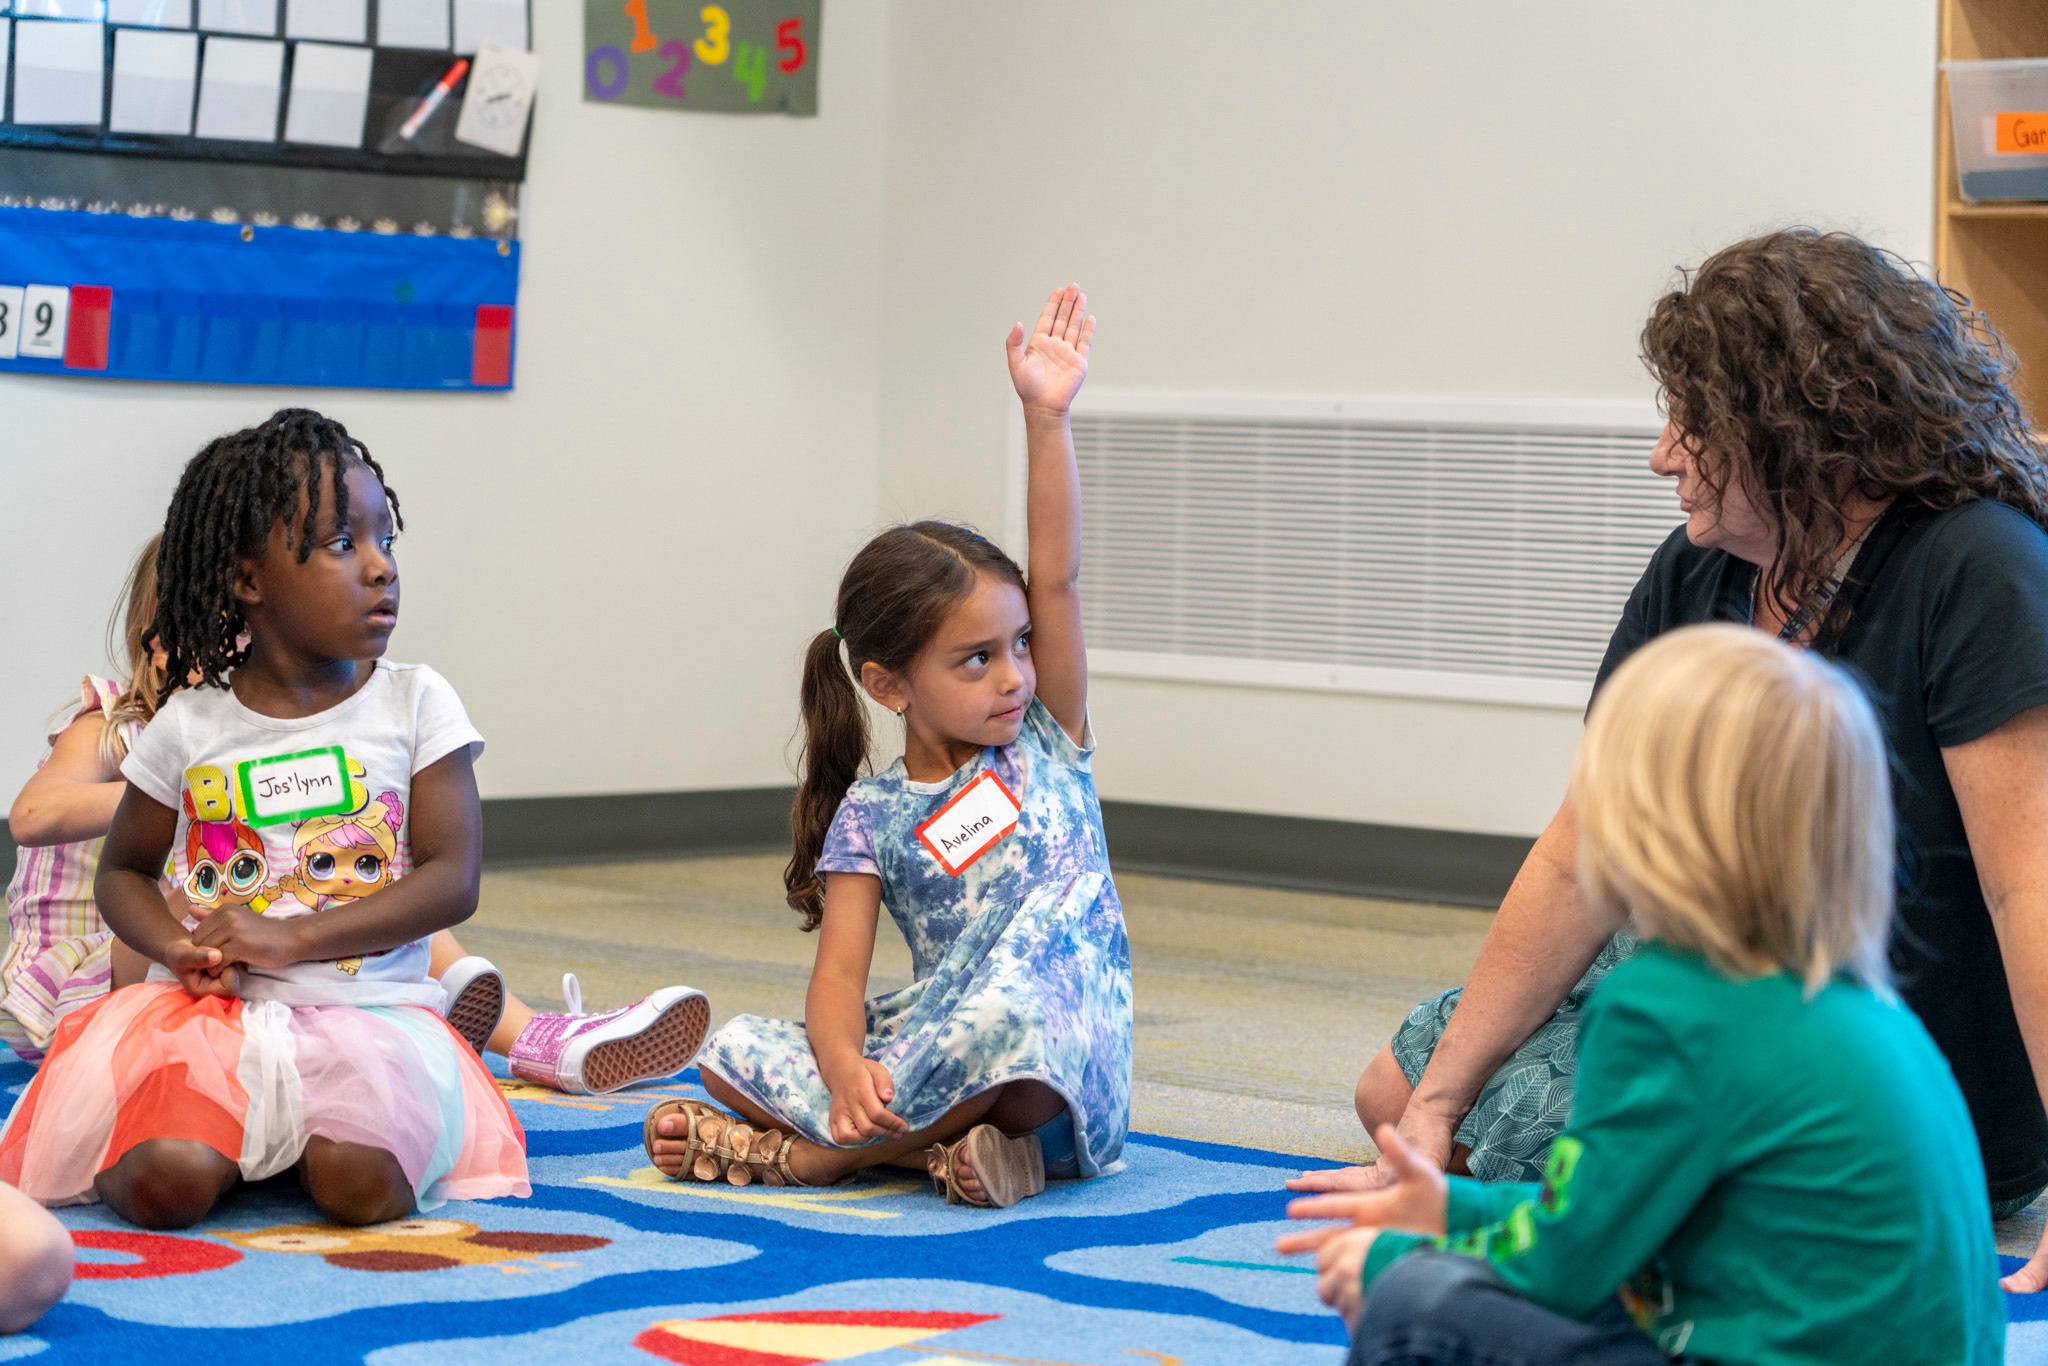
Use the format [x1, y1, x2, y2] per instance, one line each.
[0, 983, 528, 1210]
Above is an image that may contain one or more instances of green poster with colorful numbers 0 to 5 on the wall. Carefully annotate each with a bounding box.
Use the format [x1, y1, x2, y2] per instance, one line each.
[584, 0, 823, 117]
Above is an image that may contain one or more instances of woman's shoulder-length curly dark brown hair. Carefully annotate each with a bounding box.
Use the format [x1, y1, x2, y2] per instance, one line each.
[1642, 227, 2048, 625]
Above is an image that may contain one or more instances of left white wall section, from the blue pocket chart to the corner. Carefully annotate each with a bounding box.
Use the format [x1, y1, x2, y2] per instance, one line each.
[0, 0, 887, 797]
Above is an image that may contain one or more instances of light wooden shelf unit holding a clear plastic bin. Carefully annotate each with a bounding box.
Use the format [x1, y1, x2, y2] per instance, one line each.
[1933, 0, 2048, 421]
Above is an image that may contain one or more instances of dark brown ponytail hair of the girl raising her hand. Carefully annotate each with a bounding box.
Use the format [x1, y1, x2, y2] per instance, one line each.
[782, 522, 1024, 930]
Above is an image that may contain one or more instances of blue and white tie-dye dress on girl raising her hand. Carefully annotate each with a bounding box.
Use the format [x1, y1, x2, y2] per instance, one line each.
[698, 698, 1130, 1176]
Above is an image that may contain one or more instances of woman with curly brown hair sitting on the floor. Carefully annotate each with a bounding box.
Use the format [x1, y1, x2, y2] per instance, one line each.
[1290, 229, 2048, 1290]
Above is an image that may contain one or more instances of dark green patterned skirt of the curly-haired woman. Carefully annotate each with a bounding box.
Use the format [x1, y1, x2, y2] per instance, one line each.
[1393, 930, 1636, 1182]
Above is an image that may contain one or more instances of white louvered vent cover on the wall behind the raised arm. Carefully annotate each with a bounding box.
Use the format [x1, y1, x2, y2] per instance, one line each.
[1010, 391, 1679, 707]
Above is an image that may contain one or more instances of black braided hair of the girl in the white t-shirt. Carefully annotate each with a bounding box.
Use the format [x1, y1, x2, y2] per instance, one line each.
[154, 408, 406, 690]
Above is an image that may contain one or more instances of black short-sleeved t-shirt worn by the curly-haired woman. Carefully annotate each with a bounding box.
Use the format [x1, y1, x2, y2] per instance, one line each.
[1593, 502, 2048, 1200]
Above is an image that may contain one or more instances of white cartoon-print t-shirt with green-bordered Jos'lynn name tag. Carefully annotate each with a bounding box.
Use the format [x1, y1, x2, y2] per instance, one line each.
[121, 659, 483, 1008]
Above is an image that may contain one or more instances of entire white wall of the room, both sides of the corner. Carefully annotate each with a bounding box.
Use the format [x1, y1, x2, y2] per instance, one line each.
[0, 0, 1935, 834]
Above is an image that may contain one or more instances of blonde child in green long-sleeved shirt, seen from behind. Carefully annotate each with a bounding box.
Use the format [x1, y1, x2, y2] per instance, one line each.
[1280, 625, 2005, 1366]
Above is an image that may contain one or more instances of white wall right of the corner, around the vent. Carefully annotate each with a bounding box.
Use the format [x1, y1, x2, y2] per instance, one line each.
[876, 0, 1935, 834]
